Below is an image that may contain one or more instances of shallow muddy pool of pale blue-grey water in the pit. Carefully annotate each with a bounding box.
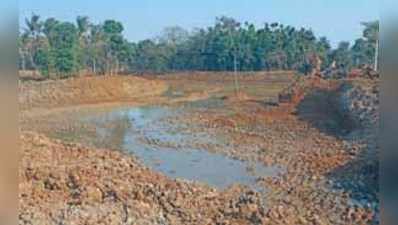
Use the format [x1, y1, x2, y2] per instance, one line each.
[84, 107, 278, 189]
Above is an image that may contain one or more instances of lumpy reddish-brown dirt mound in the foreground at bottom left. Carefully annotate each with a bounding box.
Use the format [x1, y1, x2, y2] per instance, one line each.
[19, 133, 274, 225]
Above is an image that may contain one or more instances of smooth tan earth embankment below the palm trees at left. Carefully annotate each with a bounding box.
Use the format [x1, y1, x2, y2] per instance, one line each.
[19, 76, 167, 109]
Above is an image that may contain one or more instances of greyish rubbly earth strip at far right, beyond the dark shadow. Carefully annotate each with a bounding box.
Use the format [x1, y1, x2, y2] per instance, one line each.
[332, 79, 380, 195]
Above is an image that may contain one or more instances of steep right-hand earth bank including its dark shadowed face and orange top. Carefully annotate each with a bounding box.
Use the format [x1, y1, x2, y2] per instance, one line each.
[280, 75, 380, 210]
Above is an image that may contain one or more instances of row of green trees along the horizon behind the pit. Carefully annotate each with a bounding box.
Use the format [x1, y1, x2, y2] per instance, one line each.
[19, 15, 379, 78]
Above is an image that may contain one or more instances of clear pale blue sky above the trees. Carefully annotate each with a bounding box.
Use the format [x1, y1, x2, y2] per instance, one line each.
[19, 0, 379, 46]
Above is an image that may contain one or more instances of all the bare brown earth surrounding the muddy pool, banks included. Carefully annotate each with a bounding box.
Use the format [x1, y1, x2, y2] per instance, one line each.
[20, 73, 379, 225]
